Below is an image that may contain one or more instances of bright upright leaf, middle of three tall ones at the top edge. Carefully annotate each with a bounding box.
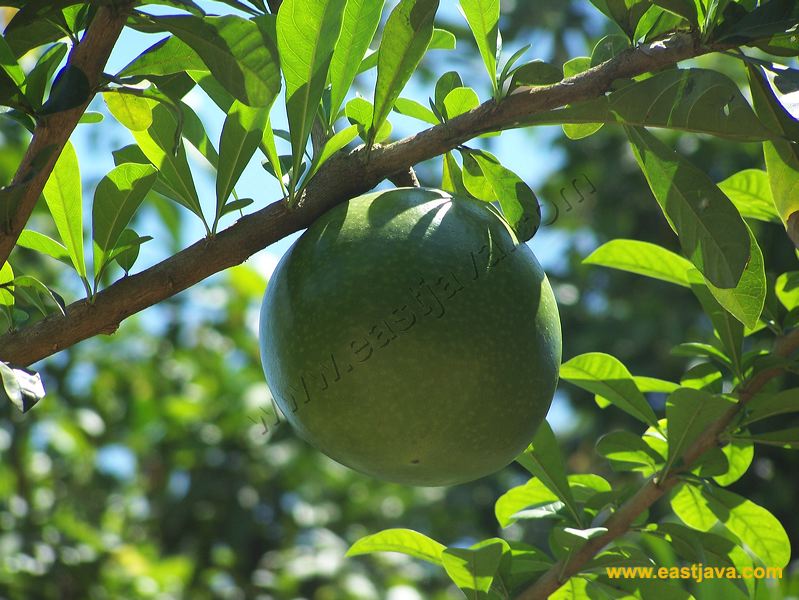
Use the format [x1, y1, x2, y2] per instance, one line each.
[328, 0, 385, 125]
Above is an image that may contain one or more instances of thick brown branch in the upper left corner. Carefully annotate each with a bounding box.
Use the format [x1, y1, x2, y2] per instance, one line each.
[0, 3, 131, 266]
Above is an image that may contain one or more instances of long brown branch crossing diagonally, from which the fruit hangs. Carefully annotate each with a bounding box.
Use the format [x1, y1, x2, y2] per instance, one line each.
[0, 33, 719, 365]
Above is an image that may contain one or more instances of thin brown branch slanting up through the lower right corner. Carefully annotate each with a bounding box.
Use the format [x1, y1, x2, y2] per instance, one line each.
[516, 329, 799, 600]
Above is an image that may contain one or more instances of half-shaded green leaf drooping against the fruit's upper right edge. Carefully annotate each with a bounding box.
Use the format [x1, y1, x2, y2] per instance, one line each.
[466, 149, 541, 242]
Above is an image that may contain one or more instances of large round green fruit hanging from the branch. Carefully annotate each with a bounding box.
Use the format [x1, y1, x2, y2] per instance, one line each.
[260, 188, 561, 485]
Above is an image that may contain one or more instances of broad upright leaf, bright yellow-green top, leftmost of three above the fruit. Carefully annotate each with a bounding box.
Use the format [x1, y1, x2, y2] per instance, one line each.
[277, 0, 346, 188]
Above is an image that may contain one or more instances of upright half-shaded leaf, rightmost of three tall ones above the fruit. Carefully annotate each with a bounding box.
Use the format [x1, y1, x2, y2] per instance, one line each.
[369, 0, 438, 144]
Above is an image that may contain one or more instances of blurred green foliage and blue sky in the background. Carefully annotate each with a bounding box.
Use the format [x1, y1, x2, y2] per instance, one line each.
[0, 0, 799, 600]
